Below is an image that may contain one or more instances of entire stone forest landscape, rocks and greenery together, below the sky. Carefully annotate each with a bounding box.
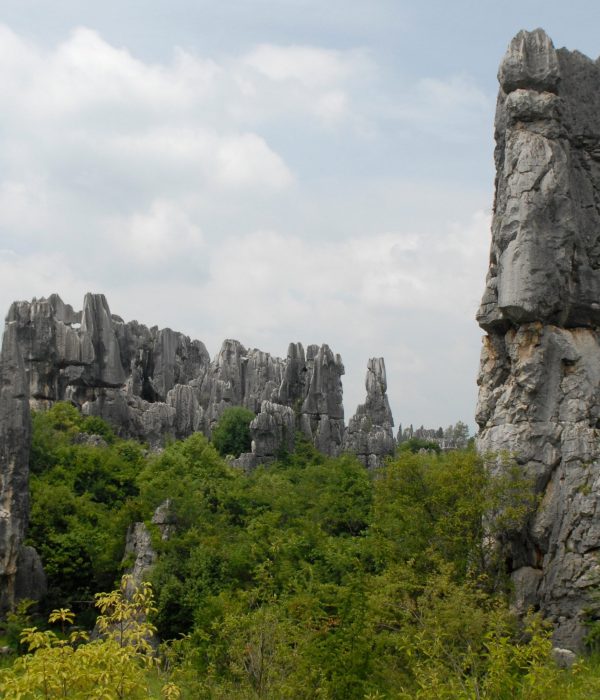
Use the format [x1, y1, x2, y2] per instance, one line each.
[0, 29, 600, 700]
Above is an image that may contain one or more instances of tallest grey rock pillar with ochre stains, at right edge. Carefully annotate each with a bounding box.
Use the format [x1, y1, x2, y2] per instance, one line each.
[477, 29, 600, 648]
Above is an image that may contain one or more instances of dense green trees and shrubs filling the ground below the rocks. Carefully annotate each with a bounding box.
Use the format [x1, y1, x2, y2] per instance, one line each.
[0, 404, 600, 700]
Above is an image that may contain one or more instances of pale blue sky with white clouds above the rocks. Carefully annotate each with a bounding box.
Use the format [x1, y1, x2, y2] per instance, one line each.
[0, 0, 600, 429]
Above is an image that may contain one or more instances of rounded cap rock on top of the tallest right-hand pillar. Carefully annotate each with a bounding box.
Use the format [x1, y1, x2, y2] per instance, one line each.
[498, 29, 560, 93]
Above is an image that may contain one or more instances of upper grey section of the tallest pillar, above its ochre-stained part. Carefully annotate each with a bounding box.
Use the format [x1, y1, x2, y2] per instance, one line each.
[478, 29, 600, 330]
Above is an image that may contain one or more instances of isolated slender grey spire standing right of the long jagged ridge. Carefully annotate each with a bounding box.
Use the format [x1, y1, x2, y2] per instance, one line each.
[344, 357, 396, 469]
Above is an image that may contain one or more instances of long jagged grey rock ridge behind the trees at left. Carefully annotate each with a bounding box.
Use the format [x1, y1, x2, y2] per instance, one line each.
[0, 294, 391, 466]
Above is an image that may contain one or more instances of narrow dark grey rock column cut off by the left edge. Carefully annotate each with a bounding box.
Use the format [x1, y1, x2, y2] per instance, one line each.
[0, 314, 46, 610]
